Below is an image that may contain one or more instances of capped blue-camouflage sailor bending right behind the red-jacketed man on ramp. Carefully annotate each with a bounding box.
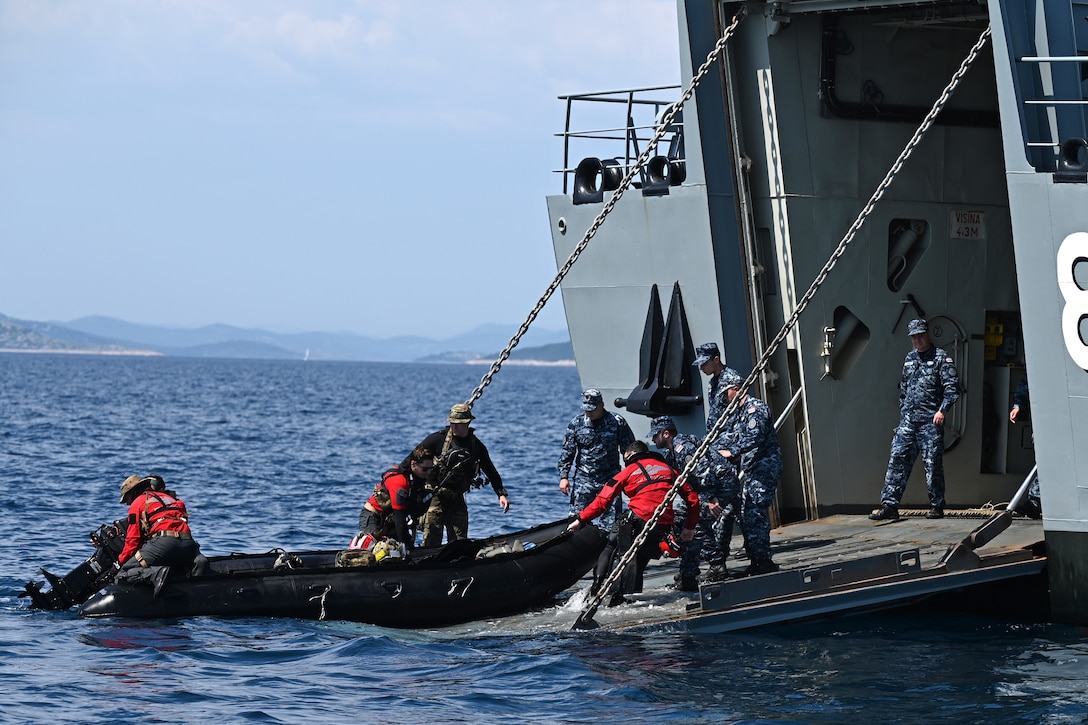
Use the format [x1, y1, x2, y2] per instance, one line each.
[650, 416, 733, 591]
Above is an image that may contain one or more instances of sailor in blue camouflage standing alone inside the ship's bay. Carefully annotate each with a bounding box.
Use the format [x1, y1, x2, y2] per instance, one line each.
[869, 320, 960, 521]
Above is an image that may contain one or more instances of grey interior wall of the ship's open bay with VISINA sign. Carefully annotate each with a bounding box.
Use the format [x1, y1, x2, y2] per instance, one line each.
[718, 3, 1033, 517]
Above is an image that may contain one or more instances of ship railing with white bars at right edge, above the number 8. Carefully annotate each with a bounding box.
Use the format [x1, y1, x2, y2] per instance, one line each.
[1017, 56, 1088, 173]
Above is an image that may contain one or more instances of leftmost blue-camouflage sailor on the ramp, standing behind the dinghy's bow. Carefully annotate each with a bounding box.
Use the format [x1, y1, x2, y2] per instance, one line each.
[558, 388, 634, 531]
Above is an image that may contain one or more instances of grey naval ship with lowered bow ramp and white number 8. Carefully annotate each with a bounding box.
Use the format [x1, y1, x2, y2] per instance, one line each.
[547, 0, 1088, 630]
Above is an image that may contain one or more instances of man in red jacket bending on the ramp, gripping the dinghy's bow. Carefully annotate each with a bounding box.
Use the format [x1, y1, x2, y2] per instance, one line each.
[567, 441, 698, 606]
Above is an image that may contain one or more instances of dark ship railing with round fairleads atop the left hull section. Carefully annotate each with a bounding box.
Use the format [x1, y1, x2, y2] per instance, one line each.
[554, 86, 685, 194]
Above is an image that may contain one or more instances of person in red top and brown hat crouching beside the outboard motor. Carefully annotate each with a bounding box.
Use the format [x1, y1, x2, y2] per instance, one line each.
[118, 475, 200, 597]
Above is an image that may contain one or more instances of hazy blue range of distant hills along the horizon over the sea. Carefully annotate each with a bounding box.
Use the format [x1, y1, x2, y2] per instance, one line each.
[0, 315, 573, 363]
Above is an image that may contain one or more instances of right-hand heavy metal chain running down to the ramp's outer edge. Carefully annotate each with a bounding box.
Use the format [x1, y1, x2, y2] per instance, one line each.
[572, 25, 990, 629]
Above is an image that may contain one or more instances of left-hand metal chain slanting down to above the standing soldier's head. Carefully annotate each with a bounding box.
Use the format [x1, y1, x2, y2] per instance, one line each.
[466, 5, 747, 407]
